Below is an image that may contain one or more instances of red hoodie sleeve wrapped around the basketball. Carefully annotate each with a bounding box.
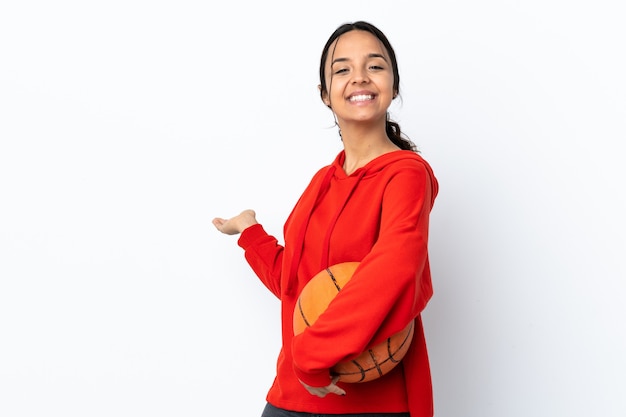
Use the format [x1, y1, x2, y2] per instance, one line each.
[292, 161, 437, 386]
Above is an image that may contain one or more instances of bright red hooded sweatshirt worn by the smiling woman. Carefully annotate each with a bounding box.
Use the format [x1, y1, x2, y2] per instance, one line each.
[238, 151, 438, 417]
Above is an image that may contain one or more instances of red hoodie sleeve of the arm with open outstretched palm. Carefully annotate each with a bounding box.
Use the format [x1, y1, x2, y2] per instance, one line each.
[237, 224, 283, 298]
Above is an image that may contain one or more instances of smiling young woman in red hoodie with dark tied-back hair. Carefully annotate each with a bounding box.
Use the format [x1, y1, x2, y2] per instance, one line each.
[213, 22, 438, 417]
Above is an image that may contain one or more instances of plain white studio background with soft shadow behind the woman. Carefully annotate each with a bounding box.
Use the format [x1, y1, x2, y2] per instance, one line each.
[0, 0, 626, 417]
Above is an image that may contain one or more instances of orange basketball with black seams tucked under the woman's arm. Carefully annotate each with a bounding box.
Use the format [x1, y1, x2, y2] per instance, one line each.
[293, 262, 414, 383]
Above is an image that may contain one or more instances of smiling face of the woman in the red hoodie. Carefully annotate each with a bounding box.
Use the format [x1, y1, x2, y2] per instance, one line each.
[322, 30, 395, 124]
